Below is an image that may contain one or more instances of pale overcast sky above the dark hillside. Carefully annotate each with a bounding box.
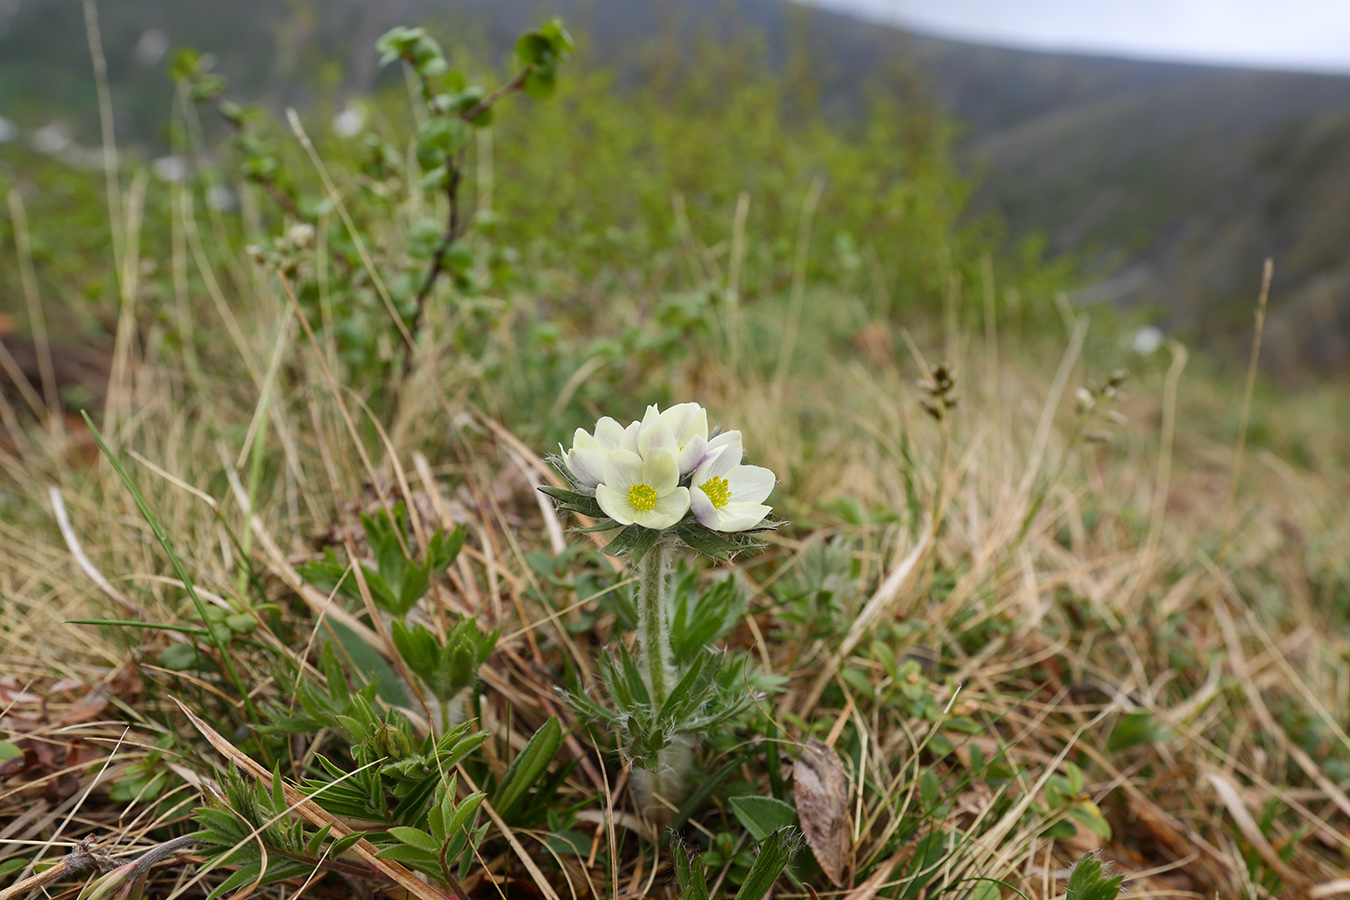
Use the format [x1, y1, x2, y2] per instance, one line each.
[810, 0, 1350, 73]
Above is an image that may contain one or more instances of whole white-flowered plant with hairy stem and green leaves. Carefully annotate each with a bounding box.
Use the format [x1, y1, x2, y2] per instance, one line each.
[539, 403, 784, 824]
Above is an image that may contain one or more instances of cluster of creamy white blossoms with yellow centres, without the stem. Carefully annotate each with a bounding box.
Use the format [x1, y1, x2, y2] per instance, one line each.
[559, 403, 776, 533]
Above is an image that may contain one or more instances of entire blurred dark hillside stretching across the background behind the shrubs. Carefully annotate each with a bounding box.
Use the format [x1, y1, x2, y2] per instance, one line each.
[0, 0, 1350, 375]
